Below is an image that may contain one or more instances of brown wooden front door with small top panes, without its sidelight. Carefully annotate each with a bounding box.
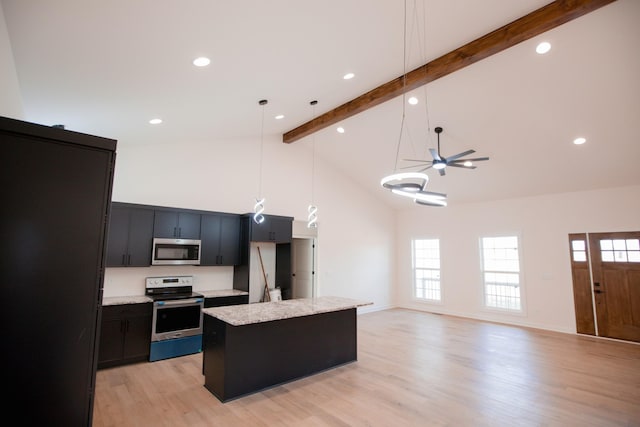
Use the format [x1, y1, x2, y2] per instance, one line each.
[589, 232, 640, 342]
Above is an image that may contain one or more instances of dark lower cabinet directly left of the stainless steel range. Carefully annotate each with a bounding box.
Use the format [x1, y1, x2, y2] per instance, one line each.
[98, 303, 153, 368]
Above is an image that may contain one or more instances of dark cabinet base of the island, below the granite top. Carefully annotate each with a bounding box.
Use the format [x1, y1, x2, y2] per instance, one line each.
[203, 308, 357, 402]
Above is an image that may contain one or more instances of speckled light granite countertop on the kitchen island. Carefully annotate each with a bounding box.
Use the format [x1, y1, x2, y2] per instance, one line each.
[202, 297, 373, 326]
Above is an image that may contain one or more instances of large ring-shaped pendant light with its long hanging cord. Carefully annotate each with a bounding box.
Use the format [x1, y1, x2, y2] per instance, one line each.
[380, 0, 447, 206]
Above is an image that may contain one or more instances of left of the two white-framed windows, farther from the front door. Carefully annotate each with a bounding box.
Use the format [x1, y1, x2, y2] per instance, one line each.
[412, 239, 442, 301]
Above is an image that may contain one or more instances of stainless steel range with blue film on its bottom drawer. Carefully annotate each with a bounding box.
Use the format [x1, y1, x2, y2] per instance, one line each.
[145, 276, 204, 362]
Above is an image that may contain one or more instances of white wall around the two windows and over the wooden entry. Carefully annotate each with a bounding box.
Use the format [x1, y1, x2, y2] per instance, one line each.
[397, 186, 640, 333]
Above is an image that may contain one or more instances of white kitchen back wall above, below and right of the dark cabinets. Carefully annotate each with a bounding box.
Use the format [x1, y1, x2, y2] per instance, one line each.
[105, 136, 395, 311]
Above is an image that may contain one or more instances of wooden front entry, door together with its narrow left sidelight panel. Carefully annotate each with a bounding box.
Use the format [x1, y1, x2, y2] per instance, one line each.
[569, 231, 640, 342]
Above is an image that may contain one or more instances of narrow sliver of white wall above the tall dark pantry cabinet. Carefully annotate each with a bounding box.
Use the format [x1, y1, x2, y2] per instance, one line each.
[0, 3, 24, 120]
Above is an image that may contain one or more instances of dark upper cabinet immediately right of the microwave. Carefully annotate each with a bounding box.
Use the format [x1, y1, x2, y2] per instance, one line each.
[200, 214, 240, 265]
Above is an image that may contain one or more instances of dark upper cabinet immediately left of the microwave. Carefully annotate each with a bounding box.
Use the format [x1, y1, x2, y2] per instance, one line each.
[107, 202, 154, 267]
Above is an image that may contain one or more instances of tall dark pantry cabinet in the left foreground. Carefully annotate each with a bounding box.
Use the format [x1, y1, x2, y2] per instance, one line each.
[0, 117, 116, 427]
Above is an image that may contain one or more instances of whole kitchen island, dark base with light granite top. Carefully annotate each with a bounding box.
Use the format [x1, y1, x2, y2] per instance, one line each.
[202, 297, 372, 402]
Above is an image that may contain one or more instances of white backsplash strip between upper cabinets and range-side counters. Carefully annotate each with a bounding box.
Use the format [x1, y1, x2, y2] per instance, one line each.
[103, 265, 233, 297]
